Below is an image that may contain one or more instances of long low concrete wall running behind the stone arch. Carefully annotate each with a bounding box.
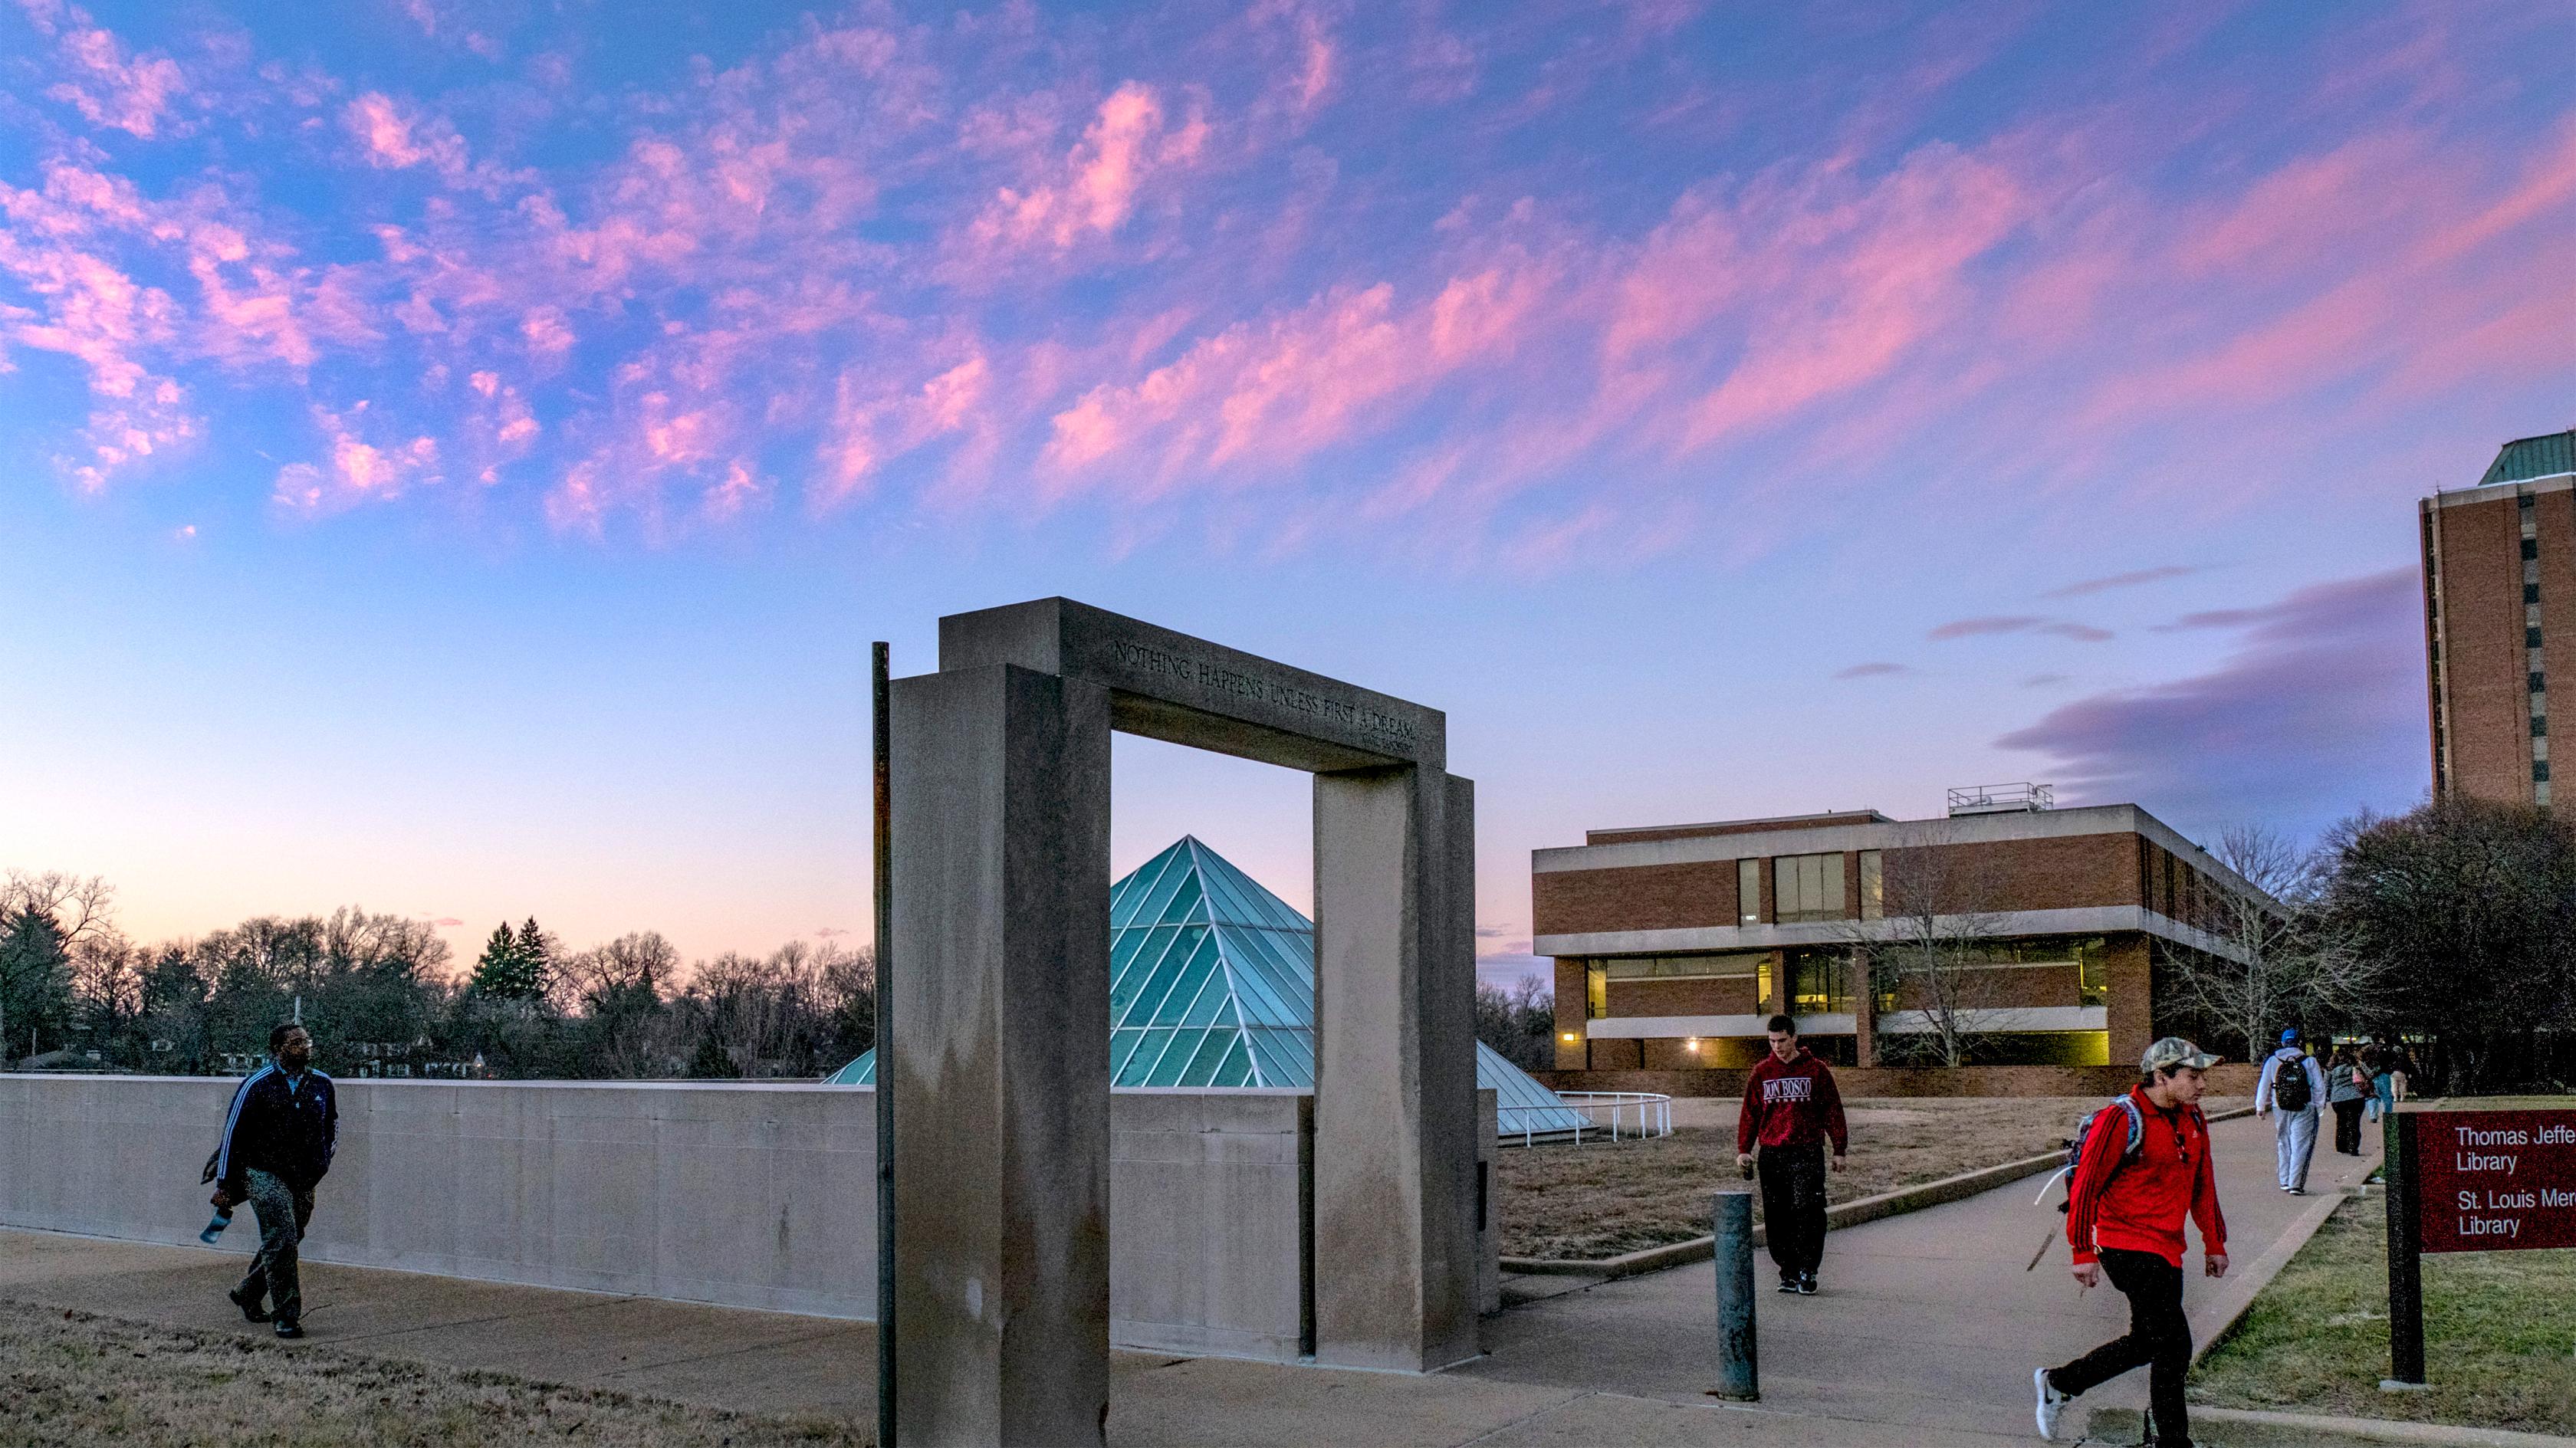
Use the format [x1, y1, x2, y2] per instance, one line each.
[0, 1075, 1329, 1358]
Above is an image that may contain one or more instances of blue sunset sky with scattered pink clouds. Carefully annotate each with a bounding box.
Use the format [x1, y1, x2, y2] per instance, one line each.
[0, 0, 2576, 977]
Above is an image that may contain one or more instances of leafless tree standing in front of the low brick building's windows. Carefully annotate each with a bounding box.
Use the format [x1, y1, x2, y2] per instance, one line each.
[1845, 829, 2017, 1067]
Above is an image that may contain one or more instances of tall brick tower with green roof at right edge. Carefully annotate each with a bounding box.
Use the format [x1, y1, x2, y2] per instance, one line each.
[2417, 430, 2576, 814]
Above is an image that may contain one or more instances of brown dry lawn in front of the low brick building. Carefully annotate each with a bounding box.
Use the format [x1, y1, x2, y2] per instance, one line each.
[1494, 1095, 2241, 1260]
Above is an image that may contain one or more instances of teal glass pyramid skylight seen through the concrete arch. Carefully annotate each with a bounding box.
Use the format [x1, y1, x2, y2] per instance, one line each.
[824, 835, 1589, 1136]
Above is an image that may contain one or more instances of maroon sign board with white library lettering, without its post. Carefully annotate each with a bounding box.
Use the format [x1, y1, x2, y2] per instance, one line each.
[2413, 1111, 2576, 1253]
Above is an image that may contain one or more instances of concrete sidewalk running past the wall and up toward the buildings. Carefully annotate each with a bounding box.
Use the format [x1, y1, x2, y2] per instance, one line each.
[0, 1121, 2370, 1448]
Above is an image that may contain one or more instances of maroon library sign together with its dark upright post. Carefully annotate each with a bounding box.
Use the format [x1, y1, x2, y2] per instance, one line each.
[2380, 1108, 2576, 1389]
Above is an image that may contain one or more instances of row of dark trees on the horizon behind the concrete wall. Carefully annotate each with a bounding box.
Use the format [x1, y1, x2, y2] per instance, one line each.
[0, 871, 876, 1079]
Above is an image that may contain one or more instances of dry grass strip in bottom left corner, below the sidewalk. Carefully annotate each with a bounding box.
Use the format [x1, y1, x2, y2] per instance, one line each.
[0, 1301, 876, 1448]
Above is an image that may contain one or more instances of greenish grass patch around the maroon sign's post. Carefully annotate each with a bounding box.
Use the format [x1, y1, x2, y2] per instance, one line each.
[2192, 1190, 2576, 1433]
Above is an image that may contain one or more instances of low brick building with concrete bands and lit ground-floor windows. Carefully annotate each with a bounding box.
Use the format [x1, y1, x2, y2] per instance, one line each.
[1530, 786, 2280, 1085]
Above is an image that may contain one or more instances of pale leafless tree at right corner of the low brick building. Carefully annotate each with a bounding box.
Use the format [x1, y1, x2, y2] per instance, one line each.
[2167, 825, 2388, 1059]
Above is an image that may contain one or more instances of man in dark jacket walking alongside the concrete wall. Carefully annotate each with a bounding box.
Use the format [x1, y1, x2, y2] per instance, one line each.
[214, 1023, 340, 1337]
